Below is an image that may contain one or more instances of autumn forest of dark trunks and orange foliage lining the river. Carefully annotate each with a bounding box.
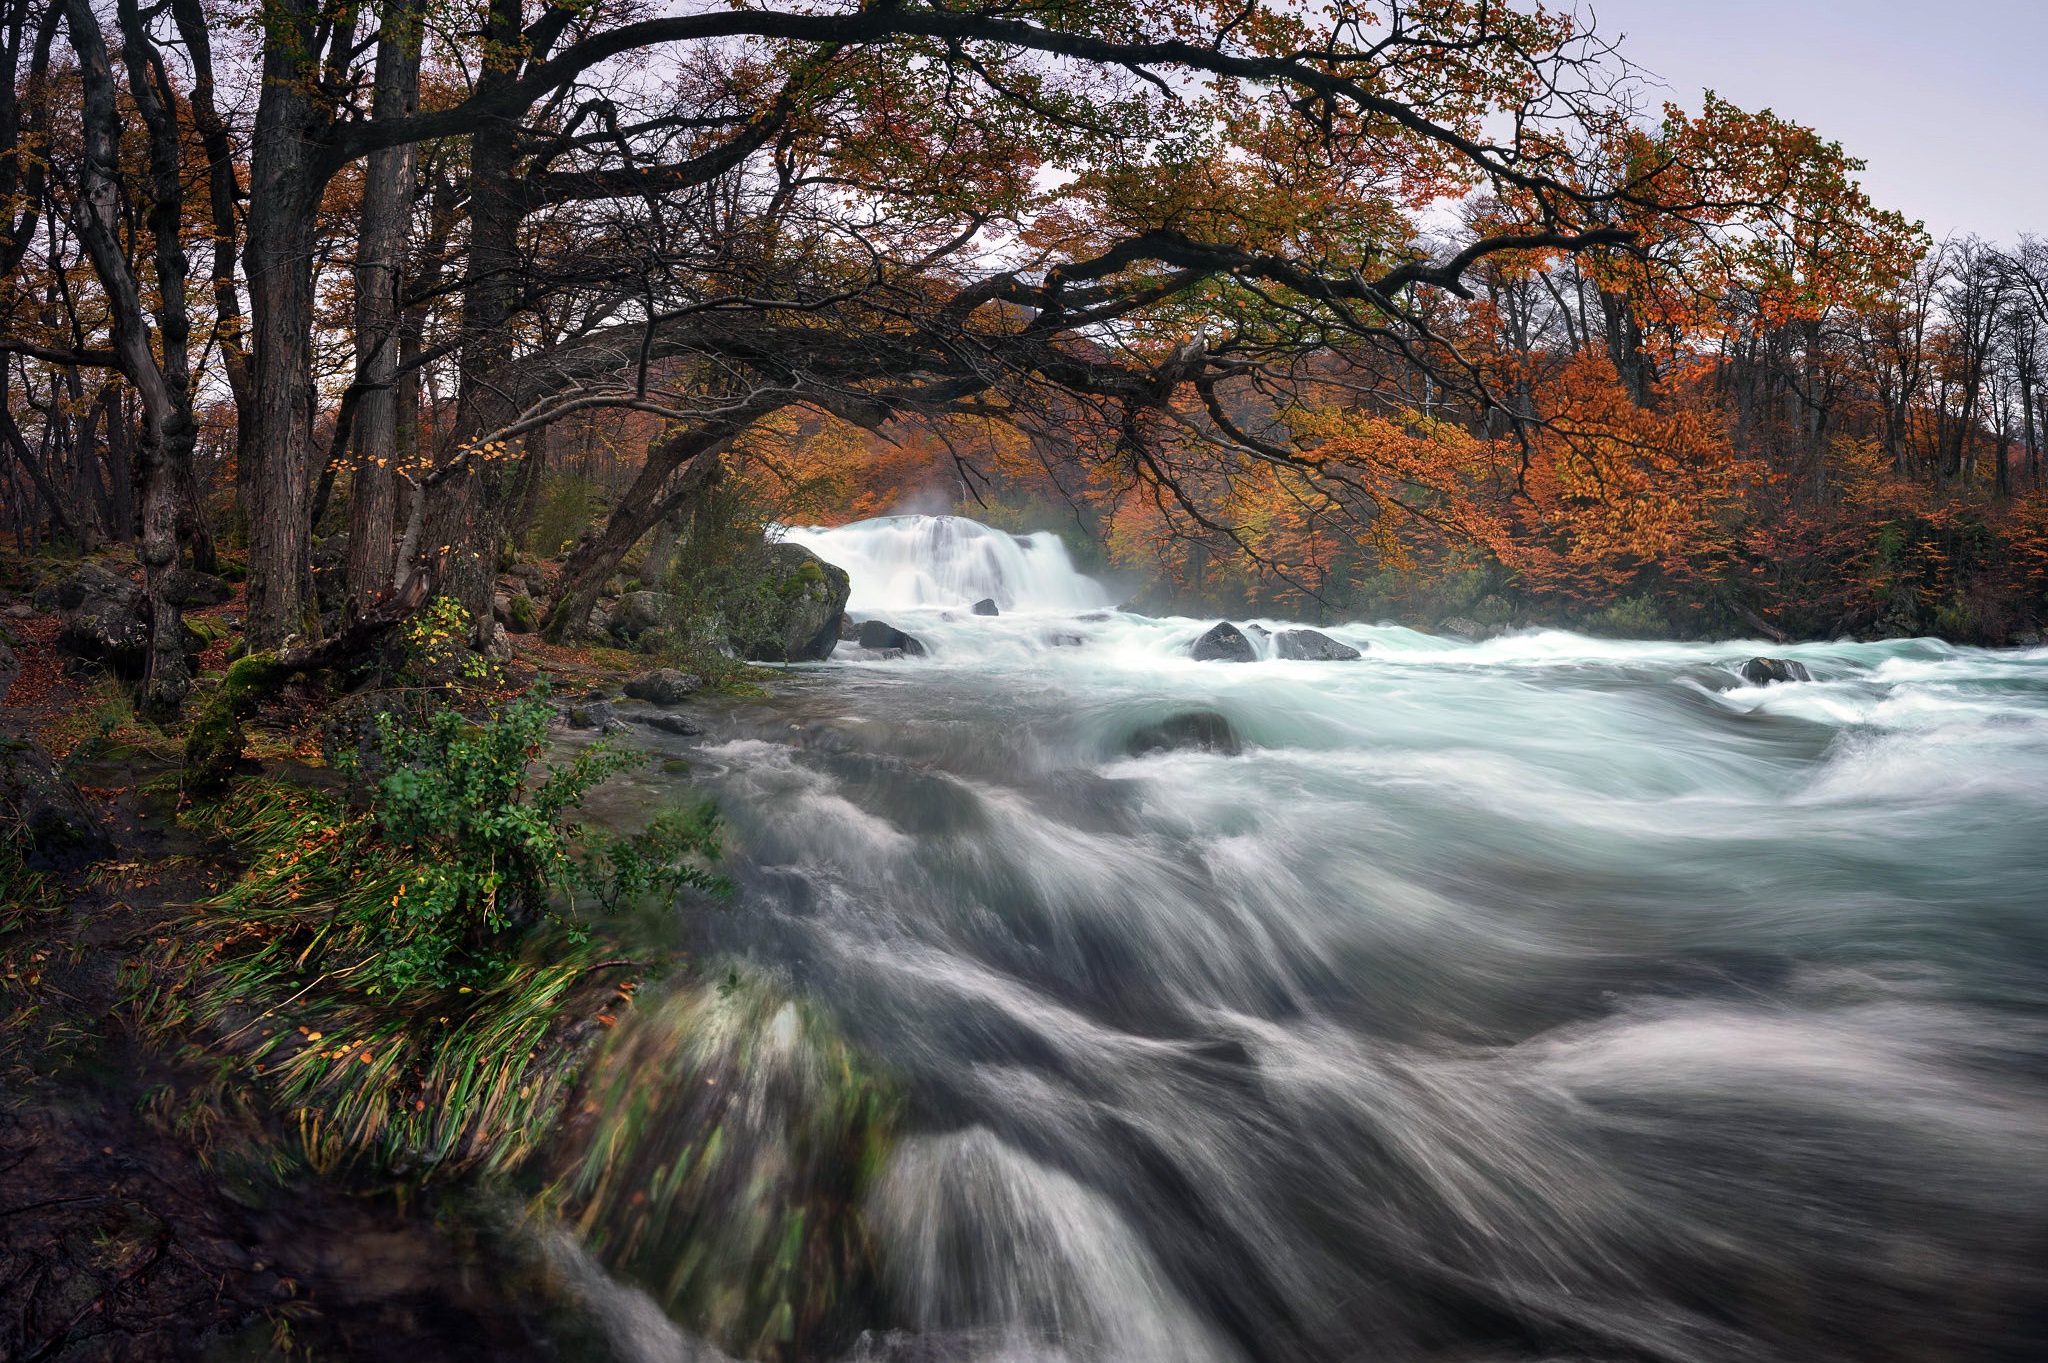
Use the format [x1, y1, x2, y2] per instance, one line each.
[0, 0, 2048, 728]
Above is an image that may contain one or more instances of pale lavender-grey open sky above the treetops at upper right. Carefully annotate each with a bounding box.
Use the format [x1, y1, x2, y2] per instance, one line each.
[1552, 0, 2048, 241]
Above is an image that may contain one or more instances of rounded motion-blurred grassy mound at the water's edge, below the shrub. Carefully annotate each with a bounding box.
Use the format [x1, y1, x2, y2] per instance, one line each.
[557, 976, 897, 1359]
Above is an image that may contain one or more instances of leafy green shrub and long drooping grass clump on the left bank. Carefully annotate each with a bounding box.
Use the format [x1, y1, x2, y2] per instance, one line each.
[159, 698, 729, 1179]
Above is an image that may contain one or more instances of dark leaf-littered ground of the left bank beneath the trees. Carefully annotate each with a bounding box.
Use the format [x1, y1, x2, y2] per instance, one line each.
[0, 552, 679, 1363]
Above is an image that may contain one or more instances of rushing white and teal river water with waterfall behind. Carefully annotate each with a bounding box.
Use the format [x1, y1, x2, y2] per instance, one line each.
[614, 518, 2048, 1363]
